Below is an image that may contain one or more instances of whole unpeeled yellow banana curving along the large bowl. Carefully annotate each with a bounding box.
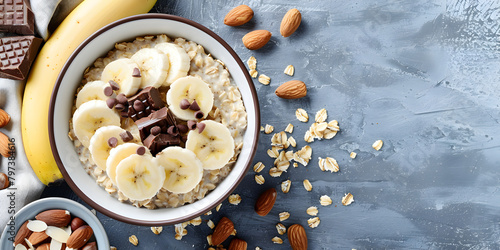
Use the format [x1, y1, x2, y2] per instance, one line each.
[21, 0, 156, 185]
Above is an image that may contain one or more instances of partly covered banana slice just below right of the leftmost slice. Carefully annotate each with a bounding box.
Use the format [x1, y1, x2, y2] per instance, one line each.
[89, 125, 126, 170]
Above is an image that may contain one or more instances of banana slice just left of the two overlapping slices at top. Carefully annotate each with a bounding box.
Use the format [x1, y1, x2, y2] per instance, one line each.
[101, 58, 142, 96]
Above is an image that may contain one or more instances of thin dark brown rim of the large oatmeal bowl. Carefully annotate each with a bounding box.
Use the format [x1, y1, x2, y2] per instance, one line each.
[48, 13, 260, 226]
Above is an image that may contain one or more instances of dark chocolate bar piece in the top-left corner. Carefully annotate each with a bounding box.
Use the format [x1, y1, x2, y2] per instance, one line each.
[0, 0, 35, 35]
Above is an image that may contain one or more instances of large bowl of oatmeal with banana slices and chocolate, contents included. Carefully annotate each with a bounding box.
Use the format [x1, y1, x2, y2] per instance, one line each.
[49, 14, 259, 225]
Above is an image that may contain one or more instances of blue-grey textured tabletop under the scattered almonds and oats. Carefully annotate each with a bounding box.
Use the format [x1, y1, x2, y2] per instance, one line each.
[47, 0, 500, 250]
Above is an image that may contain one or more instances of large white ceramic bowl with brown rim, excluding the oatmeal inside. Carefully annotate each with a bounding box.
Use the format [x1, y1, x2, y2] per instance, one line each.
[49, 14, 260, 225]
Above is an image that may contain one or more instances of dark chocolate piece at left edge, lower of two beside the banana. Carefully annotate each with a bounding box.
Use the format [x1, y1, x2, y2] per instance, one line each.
[0, 35, 42, 80]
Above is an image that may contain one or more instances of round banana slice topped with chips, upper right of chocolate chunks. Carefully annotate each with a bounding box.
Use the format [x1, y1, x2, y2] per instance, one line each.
[167, 76, 214, 121]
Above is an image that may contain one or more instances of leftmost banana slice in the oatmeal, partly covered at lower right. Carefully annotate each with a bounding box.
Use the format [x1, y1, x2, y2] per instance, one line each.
[73, 100, 120, 147]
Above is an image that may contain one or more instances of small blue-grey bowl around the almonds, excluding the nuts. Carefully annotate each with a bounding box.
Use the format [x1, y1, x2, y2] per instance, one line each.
[0, 198, 109, 250]
